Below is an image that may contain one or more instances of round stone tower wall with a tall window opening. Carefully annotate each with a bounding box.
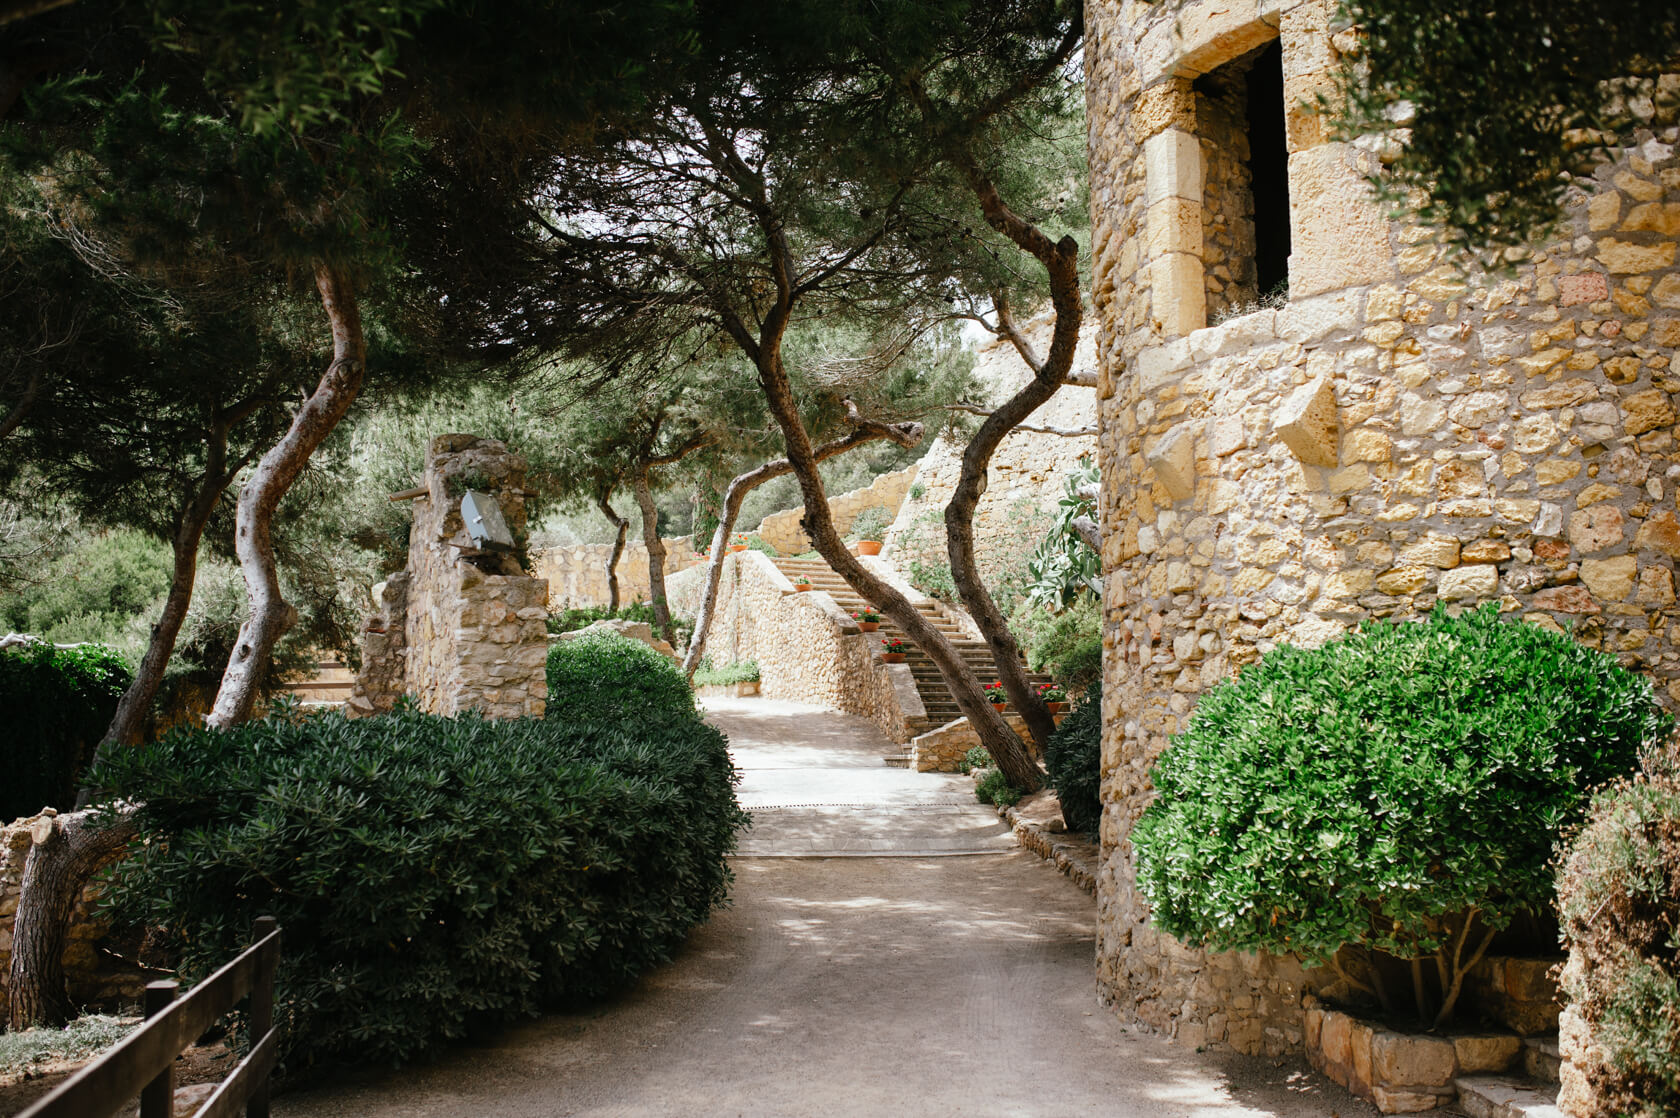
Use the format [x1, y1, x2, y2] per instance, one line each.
[1085, 0, 1680, 1052]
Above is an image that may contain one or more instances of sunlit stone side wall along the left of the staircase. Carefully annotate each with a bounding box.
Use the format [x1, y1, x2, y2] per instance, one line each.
[669, 551, 926, 743]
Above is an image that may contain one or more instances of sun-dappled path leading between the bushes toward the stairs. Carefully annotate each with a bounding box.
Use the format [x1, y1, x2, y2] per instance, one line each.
[276, 699, 1376, 1118]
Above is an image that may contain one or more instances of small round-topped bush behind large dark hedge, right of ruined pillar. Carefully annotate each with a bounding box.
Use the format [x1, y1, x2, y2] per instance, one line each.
[548, 630, 694, 721]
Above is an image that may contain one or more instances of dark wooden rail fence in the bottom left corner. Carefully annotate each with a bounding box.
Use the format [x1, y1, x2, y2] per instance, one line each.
[18, 916, 281, 1118]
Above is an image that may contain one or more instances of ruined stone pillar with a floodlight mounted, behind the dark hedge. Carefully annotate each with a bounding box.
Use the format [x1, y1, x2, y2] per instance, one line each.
[403, 435, 548, 718]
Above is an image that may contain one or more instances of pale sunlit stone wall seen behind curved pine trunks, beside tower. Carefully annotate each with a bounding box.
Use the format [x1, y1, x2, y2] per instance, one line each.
[882, 314, 1097, 580]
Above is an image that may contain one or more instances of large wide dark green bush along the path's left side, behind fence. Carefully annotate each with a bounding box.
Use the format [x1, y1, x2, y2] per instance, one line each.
[97, 711, 746, 1069]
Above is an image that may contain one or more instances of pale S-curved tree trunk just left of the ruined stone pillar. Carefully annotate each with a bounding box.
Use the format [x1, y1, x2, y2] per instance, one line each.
[205, 262, 368, 730]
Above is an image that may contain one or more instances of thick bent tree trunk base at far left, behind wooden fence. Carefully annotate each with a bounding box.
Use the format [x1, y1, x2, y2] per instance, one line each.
[7, 812, 136, 1032]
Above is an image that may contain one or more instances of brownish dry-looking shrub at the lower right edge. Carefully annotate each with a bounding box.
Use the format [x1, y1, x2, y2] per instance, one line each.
[1557, 749, 1680, 1118]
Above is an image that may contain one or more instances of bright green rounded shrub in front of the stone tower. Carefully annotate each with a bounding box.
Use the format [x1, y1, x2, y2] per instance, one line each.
[1131, 605, 1672, 1020]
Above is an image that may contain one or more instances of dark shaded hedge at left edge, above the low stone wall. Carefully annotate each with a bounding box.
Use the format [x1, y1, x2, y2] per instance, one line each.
[0, 644, 129, 822]
